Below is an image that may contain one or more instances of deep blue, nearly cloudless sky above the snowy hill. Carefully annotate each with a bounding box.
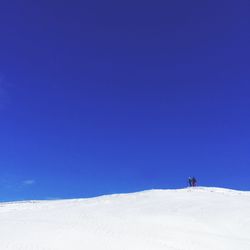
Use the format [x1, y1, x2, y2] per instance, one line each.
[0, 0, 250, 200]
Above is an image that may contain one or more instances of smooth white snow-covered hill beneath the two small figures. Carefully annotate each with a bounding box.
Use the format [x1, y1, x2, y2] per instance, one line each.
[0, 188, 250, 250]
